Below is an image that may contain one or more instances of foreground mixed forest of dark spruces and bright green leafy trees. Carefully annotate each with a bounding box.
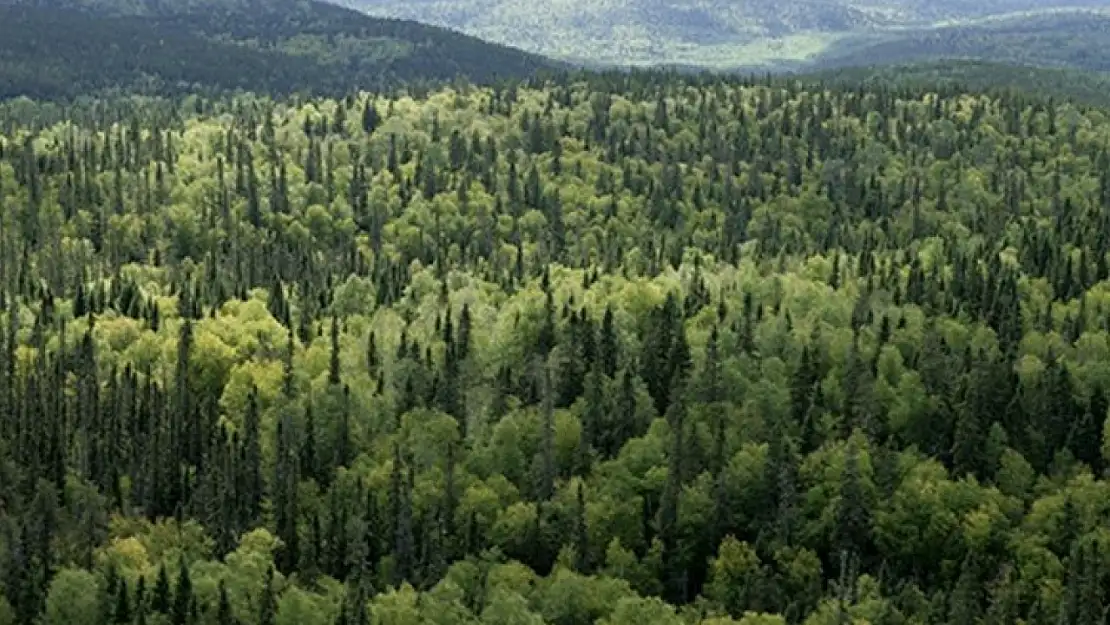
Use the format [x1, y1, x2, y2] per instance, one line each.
[0, 73, 1110, 625]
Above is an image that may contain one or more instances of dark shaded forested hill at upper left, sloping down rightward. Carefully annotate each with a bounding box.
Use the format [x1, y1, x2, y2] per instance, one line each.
[0, 0, 559, 98]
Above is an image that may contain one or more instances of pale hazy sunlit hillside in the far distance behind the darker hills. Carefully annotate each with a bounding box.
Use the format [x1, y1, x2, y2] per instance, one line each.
[336, 0, 1107, 68]
